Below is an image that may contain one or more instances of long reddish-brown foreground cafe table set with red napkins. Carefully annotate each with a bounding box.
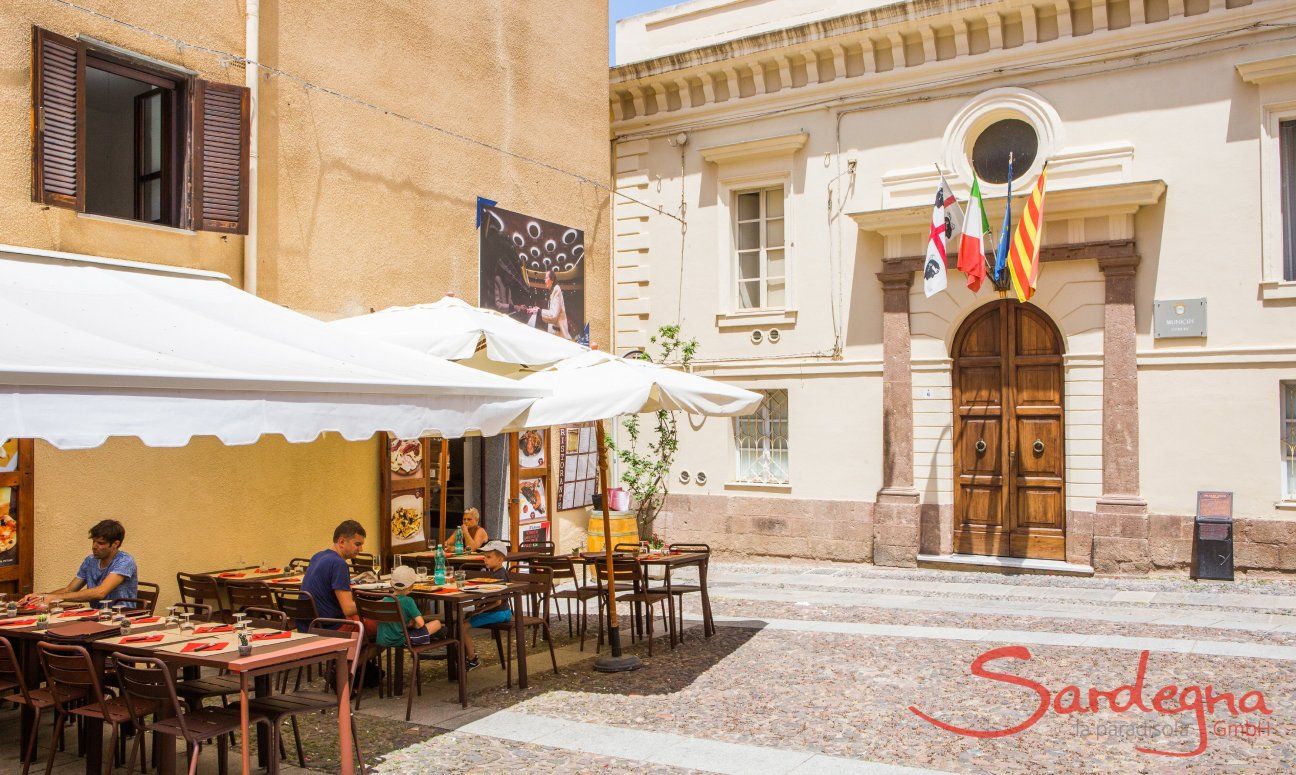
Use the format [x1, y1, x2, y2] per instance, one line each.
[0, 614, 354, 775]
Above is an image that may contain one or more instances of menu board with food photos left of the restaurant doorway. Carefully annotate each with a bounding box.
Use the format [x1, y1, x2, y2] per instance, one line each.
[378, 434, 442, 556]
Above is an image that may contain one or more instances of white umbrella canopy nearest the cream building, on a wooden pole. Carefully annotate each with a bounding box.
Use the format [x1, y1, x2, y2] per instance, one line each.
[509, 350, 761, 430]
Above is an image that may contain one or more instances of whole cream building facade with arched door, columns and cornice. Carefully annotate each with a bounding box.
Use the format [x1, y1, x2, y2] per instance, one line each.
[609, 0, 1296, 573]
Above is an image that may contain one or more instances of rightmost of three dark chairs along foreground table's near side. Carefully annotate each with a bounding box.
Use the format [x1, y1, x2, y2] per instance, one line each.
[113, 652, 273, 775]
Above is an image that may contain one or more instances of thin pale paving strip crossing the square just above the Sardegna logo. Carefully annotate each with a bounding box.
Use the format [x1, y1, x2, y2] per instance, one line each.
[712, 586, 1296, 634]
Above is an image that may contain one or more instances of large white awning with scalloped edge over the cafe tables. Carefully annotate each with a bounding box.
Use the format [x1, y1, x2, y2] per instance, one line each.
[0, 245, 546, 448]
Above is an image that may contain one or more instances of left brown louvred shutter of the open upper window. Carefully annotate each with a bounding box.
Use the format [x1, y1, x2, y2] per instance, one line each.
[31, 27, 86, 210]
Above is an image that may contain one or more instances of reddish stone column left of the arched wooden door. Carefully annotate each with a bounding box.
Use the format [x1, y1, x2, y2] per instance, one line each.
[874, 270, 919, 568]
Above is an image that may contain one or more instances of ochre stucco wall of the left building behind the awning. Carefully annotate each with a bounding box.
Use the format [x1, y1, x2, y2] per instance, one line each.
[0, 0, 610, 596]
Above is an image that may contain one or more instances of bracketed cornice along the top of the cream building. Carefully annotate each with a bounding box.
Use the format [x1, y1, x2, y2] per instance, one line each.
[609, 0, 1296, 137]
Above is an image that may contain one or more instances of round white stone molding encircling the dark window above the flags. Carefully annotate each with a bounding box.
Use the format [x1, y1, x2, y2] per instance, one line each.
[941, 88, 1063, 196]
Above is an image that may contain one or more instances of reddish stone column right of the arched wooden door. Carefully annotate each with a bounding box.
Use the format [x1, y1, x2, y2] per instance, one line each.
[1093, 255, 1152, 573]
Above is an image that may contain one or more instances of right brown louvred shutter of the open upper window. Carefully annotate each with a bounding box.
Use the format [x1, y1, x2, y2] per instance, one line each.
[193, 80, 250, 235]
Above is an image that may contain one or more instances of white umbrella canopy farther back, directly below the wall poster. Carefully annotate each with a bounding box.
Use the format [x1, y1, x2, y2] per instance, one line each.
[329, 295, 587, 376]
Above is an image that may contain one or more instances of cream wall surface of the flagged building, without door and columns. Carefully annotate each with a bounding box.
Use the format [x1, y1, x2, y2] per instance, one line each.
[612, 0, 1296, 533]
